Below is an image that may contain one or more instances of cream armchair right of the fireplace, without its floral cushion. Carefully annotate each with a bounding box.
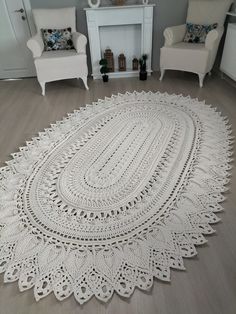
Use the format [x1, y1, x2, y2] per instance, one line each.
[160, 0, 232, 87]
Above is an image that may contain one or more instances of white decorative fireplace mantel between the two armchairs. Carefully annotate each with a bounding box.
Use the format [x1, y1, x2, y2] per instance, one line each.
[84, 4, 155, 79]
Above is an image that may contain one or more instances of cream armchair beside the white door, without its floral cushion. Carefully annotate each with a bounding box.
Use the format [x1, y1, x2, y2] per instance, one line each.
[27, 7, 88, 95]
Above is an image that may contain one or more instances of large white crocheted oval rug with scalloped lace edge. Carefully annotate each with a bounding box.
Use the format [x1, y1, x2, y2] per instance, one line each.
[0, 92, 232, 303]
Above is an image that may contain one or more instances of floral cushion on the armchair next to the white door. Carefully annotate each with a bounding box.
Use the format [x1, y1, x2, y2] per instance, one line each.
[41, 27, 74, 51]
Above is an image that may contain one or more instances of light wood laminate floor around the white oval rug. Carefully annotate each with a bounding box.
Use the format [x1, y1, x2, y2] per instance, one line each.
[0, 72, 236, 314]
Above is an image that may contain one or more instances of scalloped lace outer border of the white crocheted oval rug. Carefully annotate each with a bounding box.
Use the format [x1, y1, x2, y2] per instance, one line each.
[0, 92, 233, 304]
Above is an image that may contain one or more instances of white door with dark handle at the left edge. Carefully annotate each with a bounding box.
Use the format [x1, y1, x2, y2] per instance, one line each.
[0, 0, 35, 79]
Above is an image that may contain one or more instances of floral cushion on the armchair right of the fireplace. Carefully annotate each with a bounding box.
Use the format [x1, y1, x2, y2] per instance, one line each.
[184, 23, 218, 43]
